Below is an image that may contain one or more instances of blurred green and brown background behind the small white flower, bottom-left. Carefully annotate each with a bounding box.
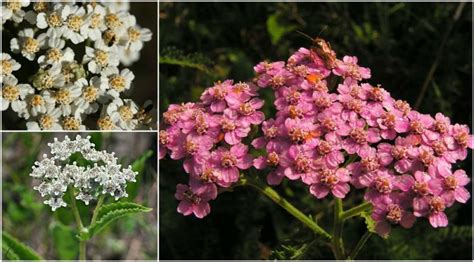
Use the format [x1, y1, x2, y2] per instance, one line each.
[2, 133, 157, 260]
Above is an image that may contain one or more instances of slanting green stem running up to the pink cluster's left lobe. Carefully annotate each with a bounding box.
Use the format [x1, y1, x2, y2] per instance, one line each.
[240, 177, 331, 239]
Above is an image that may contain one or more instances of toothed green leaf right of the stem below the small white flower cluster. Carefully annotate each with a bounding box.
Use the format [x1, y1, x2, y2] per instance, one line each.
[87, 202, 152, 238]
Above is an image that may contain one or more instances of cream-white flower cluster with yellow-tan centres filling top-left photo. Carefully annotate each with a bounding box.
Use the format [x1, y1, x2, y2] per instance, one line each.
[0, 0, 152, 130]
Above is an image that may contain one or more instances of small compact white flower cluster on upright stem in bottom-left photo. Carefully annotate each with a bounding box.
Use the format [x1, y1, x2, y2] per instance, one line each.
[30, 135, 138, 211]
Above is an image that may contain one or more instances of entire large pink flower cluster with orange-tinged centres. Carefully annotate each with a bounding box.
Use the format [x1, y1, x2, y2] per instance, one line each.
[160, 42, 474, 236]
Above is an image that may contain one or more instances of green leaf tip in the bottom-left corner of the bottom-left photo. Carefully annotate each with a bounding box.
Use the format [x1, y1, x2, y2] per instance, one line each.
[2, 231, 43, 260]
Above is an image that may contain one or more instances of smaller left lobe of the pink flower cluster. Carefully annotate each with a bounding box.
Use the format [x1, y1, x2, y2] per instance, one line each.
[160, 80, 265, 218]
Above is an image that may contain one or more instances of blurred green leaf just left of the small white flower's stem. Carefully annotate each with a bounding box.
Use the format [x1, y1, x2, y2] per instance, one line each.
[51, 223, 79, 260]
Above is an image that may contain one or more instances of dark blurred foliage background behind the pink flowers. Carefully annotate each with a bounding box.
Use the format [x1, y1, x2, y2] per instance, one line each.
[159, 3, 472, 259]
